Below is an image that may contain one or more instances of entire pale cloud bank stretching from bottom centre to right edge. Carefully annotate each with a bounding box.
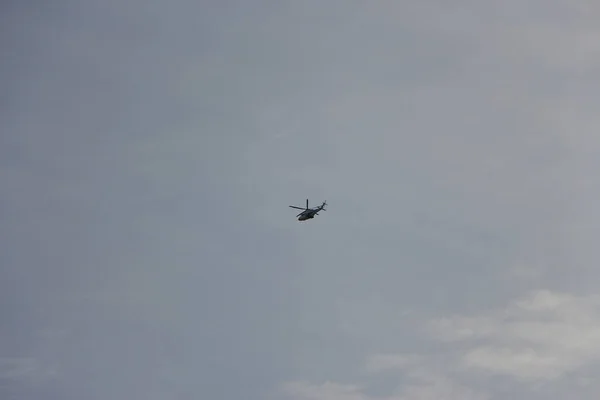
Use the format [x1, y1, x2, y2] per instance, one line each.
[281, 290, 600, 400]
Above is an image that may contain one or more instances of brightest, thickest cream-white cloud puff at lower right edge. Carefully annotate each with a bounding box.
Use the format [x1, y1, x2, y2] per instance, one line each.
[429, 290, 600, 381]
